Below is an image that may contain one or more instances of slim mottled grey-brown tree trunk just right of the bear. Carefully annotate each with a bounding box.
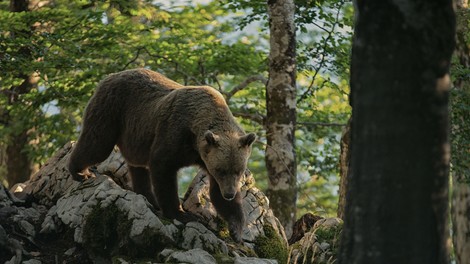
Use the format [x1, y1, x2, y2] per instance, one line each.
[266, 0, 297, 237]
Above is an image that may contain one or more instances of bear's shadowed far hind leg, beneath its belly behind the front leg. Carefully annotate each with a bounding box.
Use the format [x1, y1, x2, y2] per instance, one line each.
[129, 166, 159, 210]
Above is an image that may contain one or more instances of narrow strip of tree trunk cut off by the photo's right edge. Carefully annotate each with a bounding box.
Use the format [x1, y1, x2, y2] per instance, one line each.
[451, 1, 470, 264]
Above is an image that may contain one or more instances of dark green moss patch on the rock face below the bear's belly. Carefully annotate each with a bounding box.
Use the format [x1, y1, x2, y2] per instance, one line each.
[83, 204, 168, 258]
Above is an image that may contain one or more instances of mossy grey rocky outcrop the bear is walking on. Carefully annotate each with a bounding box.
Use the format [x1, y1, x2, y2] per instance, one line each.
[0, 144, 287, 263]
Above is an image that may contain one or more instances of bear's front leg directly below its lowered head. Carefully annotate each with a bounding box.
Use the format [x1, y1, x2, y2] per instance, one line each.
[209, 175, 245, 243]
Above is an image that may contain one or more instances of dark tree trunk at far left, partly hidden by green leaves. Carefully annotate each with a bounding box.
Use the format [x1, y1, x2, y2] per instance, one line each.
[2, 0, 33, 186]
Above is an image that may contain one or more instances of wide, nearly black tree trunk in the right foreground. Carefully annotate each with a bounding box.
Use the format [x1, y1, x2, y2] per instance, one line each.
[339, 0, 455, 264]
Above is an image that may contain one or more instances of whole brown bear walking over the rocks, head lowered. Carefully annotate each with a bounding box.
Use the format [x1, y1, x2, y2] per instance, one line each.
[68, 69, 256, 242]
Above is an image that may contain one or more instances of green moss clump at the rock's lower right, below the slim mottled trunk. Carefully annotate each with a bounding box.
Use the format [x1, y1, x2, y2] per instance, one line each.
[255, 225, 288, 264]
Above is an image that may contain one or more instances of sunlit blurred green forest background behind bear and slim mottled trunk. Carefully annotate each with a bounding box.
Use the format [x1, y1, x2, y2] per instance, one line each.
[0, 0, 352, 220]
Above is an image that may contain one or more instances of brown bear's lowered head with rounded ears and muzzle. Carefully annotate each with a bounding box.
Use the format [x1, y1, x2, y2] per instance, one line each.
[200, 130, 256, 201]
